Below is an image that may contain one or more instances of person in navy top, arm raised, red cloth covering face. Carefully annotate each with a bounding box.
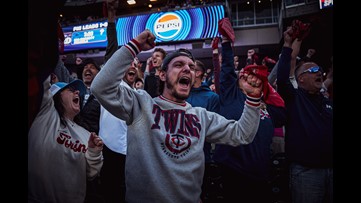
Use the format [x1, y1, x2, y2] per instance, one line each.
[214, 17, 286, 203]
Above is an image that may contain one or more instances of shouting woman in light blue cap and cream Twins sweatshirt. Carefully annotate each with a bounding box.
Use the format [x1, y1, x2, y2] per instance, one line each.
[28, 77, 103, 203]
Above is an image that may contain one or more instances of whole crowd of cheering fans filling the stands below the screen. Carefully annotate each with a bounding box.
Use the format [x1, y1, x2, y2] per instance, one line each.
[28, 0, 333, 203]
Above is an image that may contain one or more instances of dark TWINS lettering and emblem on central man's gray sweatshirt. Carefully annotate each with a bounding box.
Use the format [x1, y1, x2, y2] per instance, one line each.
[151, 105, 201, 159]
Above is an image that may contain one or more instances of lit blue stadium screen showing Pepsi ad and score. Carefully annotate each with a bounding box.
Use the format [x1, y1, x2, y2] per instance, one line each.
[63, 5, 225, 52]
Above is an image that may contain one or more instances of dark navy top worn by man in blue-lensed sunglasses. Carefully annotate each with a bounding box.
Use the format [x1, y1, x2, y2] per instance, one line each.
[277, 47, 333, 168]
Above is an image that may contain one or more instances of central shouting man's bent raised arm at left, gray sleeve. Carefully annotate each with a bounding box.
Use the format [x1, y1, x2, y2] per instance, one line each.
[90, 30, 155, 120]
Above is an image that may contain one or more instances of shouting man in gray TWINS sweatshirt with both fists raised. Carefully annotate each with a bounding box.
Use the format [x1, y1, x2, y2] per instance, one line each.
[91, 30, 262, 203]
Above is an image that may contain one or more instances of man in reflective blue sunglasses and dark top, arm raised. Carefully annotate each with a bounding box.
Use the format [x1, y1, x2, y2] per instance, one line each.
[277, 28, 333, 203]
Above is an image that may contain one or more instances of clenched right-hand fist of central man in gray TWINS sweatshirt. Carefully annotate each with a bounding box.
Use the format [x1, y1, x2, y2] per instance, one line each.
[240, 73, 263, 97]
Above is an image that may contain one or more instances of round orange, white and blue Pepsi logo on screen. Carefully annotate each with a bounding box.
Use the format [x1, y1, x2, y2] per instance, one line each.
[154, 12, 183, 40]
